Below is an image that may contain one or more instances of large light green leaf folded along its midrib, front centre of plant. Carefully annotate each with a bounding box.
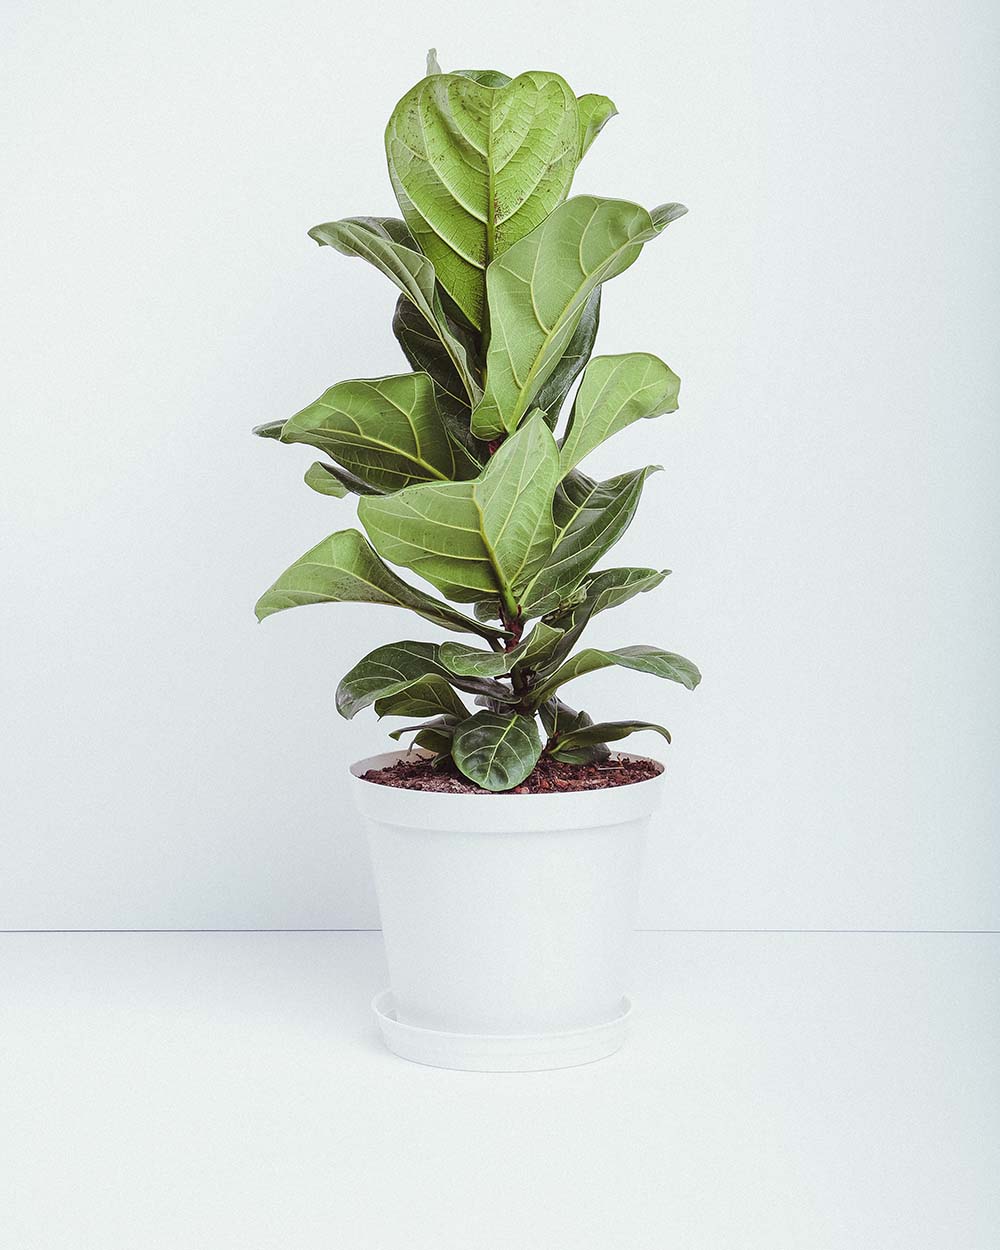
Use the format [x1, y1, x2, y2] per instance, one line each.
[358, 414, 559, 615]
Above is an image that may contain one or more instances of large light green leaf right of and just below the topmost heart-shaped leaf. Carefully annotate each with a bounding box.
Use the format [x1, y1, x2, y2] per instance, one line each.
[473, 195, 665, 439]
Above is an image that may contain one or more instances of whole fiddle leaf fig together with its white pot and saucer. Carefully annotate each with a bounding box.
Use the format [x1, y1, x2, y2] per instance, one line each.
[255, 54, 699, 1070]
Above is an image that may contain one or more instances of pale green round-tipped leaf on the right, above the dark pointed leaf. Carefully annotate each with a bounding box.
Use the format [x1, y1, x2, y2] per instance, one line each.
[559, 351, 680, 474]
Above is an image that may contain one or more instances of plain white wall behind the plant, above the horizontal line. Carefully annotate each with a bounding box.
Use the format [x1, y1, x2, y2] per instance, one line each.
[0, 0, 1000, 929]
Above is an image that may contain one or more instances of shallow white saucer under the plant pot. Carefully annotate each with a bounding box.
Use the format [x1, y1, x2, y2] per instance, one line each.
[371, 990, 633, 1073]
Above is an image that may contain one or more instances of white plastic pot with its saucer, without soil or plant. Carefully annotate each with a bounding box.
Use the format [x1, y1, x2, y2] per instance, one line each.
[351, 751, 664, 1071]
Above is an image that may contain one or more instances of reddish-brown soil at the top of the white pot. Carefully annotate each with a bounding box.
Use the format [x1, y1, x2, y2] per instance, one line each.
[364, 755, 660, 794]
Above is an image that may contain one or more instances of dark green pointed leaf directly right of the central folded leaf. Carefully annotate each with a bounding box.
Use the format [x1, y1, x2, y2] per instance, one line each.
[523, 465, 660, 616]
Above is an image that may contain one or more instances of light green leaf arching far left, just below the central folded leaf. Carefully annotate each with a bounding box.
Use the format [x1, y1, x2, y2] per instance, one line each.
[255, 530, 504, 639]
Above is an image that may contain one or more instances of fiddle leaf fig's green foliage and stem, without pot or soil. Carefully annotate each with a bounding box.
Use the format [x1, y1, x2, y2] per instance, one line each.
[254, 55, 700, 791]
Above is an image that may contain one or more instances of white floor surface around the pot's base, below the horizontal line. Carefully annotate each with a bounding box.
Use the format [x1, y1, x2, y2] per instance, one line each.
[0, 933, 1000, 1250]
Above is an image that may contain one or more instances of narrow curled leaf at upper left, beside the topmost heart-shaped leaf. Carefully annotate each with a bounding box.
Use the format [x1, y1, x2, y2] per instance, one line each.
[309, 218, 481, 404]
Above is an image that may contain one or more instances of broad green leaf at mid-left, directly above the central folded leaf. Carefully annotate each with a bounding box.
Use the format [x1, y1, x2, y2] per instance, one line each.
[281, 374, 480, 491]
